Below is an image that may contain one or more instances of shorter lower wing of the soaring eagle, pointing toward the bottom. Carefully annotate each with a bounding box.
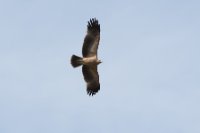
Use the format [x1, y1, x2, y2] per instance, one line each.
[82, 65, 100, 95]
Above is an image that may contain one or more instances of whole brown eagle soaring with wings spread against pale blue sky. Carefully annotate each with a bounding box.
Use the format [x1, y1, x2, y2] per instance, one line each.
[71, 18, 102, 96]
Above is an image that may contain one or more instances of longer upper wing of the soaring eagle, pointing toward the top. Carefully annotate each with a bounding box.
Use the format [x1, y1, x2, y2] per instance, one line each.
[82, 18, 100, 57]
